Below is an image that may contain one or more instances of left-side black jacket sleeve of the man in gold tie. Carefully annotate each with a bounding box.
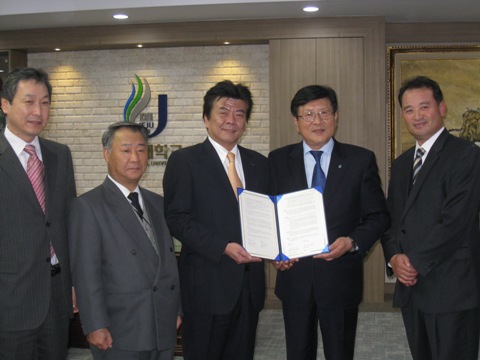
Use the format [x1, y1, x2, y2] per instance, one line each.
[163, 151, 228, 263]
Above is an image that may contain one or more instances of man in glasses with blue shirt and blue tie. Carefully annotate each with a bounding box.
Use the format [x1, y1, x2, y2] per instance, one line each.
[268, 85, 390, 360]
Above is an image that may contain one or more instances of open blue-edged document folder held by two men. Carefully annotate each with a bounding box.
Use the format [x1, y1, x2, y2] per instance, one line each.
[238, 188, 328, 261]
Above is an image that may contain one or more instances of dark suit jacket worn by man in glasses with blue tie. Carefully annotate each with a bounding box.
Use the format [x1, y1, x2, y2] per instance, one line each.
[268, 141, 390, 309]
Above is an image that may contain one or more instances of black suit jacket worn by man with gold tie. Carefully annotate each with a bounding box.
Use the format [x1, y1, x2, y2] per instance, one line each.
[163, 139, 267, 314]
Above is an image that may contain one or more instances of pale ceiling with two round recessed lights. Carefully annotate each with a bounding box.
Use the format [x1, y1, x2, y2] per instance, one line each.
[0, 0, 480, 30]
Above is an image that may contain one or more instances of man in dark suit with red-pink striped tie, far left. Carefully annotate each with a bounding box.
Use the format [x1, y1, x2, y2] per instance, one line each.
[0, 68, 76, 360]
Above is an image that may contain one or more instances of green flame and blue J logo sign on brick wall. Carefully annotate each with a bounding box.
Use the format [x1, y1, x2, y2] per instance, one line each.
[123, 74, 168, 138]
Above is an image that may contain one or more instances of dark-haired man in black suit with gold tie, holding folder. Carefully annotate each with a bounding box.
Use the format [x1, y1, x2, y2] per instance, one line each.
[163, 80, 267, 360]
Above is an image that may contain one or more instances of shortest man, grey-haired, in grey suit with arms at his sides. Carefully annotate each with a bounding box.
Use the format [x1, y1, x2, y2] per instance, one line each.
[68, 122, 180, 360]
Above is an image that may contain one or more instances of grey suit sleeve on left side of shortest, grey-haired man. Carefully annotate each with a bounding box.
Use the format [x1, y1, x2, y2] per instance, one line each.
[68, 197, 110, 334]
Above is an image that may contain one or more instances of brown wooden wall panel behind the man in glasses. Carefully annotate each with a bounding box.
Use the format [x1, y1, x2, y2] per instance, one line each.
[268, 20, 387, 303]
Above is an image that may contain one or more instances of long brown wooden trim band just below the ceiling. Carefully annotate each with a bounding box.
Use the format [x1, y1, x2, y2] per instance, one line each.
[0, 17, 384, 52]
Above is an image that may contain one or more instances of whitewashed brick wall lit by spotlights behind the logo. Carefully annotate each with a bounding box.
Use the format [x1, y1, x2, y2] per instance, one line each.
[28, 45, 269, 194]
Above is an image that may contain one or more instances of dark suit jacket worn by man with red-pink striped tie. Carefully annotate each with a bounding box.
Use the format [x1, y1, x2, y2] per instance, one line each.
[0, 132, 76, 331]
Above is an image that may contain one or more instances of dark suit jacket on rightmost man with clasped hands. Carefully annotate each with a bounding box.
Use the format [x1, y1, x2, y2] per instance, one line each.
[382, 130, 480, 313]
